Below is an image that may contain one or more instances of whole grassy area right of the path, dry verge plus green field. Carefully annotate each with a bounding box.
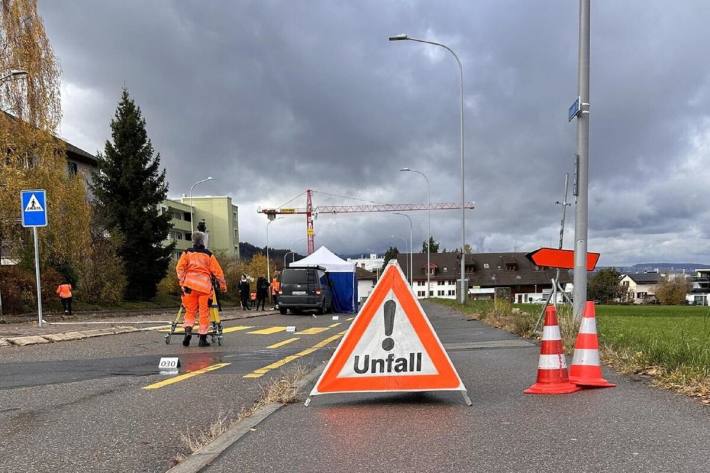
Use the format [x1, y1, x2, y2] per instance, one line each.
[432, 299, 710, 405]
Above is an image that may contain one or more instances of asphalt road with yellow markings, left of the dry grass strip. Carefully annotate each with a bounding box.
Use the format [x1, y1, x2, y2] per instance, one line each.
[0, 314, 349, 472]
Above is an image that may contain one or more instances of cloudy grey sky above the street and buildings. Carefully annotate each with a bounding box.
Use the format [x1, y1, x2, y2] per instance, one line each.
[39, 0, 710, 265]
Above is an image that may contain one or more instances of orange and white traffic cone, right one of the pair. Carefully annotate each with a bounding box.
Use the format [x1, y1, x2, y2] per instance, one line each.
[569, 301, 616, 388]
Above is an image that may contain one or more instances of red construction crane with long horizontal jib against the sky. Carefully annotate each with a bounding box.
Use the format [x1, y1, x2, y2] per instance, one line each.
[257, 189, 474, 255]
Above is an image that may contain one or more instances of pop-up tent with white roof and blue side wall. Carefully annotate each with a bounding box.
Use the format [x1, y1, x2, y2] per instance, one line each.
[289, 246, 357, 313]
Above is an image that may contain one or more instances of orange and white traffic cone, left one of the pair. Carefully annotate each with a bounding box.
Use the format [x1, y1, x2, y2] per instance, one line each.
[523, 305, 580, 394]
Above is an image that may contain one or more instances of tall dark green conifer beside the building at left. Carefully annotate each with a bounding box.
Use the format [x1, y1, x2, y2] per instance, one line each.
[93, 89, 175, 299]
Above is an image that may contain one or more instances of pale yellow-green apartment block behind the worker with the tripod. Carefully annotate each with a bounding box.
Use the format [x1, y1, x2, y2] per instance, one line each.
[160, 196, 239, 258]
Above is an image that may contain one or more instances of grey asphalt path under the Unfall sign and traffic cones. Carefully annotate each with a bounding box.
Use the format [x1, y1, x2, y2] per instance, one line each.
[207, 305, 710, 473]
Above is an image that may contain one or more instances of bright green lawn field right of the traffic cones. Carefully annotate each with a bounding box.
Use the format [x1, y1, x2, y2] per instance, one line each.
[597, 305, 710, 376]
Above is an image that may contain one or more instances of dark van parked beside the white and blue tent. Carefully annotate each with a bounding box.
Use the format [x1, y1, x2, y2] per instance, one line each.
[278, 266, 333, 314]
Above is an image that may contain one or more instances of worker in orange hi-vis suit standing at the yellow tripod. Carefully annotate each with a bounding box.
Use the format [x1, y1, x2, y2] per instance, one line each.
[176, 232, 227, 347]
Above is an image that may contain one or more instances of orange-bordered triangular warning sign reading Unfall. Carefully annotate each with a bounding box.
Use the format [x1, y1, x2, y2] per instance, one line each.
[311, 261, 466, 397]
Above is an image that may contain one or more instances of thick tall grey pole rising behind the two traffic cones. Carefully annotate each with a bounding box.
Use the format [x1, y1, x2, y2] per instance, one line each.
[574, 0, 590, 319]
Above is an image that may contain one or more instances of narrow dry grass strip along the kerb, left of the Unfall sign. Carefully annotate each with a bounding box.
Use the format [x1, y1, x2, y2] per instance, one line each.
[171, 365, 308, 467]
